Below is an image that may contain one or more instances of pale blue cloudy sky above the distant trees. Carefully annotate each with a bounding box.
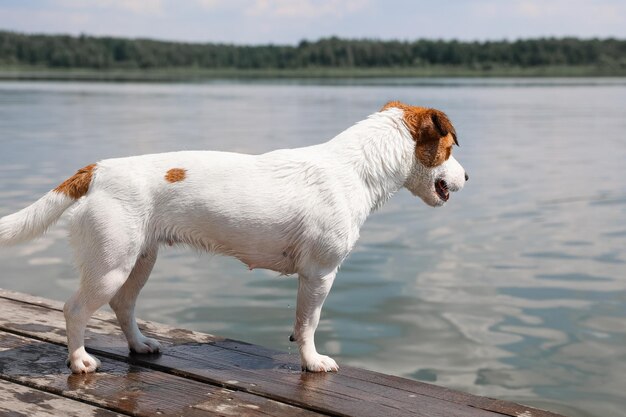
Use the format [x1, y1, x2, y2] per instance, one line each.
[0, 0, 626, 44]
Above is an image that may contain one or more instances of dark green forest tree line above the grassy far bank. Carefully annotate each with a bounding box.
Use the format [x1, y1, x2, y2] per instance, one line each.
[0, 31, 626, 70]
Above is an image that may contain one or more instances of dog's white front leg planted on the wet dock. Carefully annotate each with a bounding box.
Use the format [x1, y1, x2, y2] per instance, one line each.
[291, 270, 339, 372]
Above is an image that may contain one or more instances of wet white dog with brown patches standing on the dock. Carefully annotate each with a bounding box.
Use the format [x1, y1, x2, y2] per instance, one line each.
[0, 101, 468, 373]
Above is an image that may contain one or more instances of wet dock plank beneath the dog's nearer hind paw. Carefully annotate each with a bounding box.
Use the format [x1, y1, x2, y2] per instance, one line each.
[0, 330, 318, 417]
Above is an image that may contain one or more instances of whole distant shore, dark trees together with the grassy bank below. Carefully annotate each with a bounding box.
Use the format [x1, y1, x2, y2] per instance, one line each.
[0, 30, 626, 82]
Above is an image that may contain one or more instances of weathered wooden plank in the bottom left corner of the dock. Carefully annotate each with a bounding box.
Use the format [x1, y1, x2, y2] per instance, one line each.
[0, 380, 122, 417]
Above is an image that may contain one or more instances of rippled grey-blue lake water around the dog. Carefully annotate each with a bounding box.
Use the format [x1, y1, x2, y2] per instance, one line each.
[0, 79, 626, 417]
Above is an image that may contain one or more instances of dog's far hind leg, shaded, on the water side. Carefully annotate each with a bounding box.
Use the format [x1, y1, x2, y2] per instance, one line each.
[109, 244, 161, 353]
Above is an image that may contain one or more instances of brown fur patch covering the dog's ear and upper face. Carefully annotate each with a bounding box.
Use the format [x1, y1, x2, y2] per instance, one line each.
[380, 101, 458, 168]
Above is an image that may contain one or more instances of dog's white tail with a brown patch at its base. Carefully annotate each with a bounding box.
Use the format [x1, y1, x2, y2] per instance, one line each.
[0, 164, 96, 246]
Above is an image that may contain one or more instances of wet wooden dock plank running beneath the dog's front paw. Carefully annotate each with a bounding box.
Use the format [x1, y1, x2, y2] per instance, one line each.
[0, 292, 496, 417]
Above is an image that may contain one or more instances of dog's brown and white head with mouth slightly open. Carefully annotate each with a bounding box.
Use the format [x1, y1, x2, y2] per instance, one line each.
[381, 101, 469, 207]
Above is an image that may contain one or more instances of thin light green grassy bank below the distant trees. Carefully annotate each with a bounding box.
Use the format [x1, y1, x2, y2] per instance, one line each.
[0, 66, 626, 82]
